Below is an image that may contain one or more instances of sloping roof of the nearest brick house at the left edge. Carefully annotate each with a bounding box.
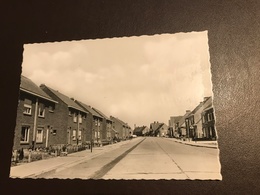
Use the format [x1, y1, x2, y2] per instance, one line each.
[20, 75, 58, 103]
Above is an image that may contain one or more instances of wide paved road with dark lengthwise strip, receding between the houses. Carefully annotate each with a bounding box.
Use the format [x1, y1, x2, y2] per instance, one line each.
[39, 137, 221, 179]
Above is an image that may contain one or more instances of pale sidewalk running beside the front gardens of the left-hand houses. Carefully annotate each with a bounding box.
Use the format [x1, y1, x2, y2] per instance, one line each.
[10, 140, 136, 178]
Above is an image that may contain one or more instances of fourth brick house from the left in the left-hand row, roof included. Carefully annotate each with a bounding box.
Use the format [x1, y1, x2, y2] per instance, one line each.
[93, 108, 113, 141]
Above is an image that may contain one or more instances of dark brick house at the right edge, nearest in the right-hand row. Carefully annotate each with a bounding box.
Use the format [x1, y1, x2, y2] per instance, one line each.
[201, 105, 217, 140]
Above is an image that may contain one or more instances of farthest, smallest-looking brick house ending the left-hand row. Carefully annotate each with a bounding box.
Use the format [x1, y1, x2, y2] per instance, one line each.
[110, 116, 131, 140]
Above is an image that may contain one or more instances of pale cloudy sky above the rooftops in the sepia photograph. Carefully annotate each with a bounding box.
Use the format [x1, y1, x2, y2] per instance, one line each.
[22, 31, 213, 128]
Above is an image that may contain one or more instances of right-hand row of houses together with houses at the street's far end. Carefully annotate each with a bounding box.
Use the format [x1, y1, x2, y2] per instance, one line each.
[133, 97, 217, 140]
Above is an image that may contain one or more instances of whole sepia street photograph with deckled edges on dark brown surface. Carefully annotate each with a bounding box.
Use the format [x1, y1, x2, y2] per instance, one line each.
[10, 31, 222, 180]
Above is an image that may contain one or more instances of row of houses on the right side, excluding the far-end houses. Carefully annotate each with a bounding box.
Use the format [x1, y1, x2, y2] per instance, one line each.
[169, 97, 217, 140]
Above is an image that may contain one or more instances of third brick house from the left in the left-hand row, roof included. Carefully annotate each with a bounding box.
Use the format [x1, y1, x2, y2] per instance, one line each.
[75, 100, 104, 143]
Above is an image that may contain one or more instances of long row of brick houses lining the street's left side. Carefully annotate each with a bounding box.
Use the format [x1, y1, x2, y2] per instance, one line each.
[13, 76, 131, 150]
